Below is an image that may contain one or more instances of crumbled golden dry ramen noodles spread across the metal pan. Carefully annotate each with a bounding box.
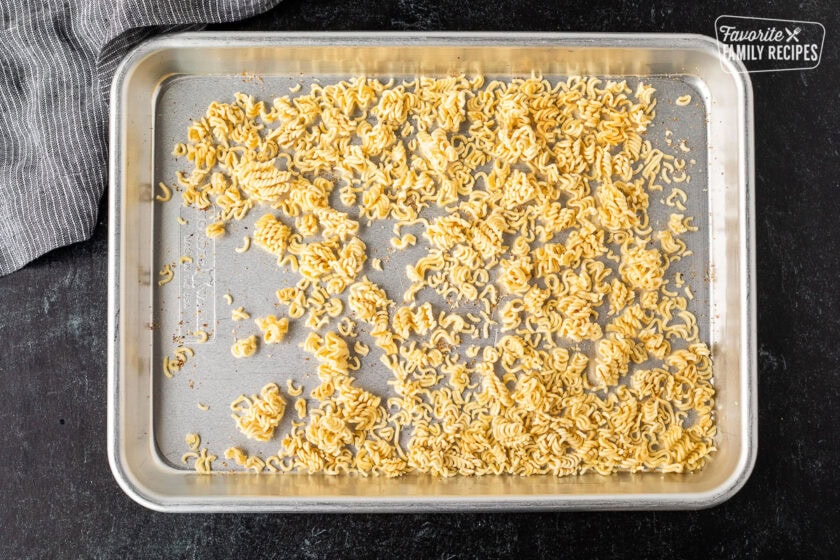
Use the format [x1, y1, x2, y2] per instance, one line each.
[173, 76, 716, 476]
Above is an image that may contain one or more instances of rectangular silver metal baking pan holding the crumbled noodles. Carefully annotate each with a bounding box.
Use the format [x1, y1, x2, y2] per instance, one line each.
[108, 33, 757, 512]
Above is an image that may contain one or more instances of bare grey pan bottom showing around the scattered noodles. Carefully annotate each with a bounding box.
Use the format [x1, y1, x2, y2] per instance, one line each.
[151, 74, 713, 469]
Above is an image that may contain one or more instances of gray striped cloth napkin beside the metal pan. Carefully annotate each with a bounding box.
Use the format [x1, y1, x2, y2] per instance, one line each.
[0, 0, 279, 275]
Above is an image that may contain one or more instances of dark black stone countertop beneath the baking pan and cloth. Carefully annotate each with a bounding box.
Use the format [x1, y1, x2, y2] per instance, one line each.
[0, 0, 840, 558]
